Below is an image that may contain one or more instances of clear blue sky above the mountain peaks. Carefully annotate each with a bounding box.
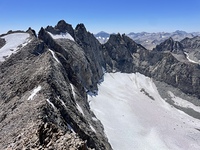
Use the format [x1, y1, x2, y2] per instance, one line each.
[0, 0, 200, 34]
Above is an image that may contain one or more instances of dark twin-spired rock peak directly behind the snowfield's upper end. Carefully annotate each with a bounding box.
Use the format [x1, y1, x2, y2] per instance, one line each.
[103, 34, 146, 73]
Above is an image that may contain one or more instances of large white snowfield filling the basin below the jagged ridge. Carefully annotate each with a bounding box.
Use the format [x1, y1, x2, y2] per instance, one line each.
[88, 73, 200, 150]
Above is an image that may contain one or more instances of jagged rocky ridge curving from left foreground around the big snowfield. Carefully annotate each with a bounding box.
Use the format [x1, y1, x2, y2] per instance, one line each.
[0, 20, 200, 150]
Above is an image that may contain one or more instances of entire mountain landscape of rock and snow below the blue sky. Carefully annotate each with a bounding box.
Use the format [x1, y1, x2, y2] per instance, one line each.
[0, 20, 200, 150]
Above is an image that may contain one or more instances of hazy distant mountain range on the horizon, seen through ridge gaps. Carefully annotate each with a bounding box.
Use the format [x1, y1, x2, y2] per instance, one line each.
[95, 30, 200, 50]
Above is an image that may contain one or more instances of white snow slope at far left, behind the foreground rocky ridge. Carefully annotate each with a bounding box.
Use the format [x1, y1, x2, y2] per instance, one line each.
[0, 33, 30, 62]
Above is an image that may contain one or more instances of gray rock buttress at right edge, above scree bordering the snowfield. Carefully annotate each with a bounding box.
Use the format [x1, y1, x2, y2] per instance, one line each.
[151, 54, 200, 98]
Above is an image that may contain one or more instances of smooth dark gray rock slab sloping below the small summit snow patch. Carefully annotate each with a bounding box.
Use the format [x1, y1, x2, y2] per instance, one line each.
[39, 26, 98, 91]
